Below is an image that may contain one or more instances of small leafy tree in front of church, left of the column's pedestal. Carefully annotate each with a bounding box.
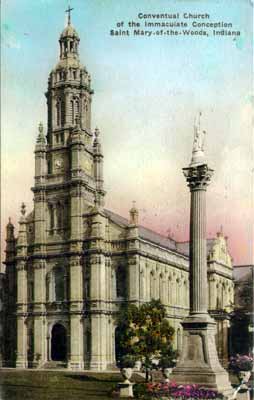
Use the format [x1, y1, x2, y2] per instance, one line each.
[117, 300, 176, 381]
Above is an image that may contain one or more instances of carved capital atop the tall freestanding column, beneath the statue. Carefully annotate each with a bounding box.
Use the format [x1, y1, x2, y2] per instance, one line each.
[183, 164, 214, 191]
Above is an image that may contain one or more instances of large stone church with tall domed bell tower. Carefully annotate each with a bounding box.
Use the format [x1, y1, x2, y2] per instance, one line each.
[1, 21, 234, 371]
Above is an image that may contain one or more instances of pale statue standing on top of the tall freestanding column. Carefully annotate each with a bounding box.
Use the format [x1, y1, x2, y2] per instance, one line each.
[190, 111, 206, 167]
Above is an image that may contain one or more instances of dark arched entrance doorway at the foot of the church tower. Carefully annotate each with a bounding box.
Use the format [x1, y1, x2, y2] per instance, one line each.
[51, 324, 67, 361]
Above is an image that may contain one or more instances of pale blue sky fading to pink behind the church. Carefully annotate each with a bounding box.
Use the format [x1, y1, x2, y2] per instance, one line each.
[1, 0, 253, 263]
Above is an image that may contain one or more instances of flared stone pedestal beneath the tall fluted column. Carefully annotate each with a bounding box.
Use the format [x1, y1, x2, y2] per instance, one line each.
[171, 315, 233, 397]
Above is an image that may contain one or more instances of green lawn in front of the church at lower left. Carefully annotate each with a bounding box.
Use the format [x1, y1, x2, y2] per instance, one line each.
[0, 369, 122, 400]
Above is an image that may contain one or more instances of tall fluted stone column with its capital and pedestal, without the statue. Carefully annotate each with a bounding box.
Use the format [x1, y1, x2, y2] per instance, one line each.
[173, 163, 232, 396]
